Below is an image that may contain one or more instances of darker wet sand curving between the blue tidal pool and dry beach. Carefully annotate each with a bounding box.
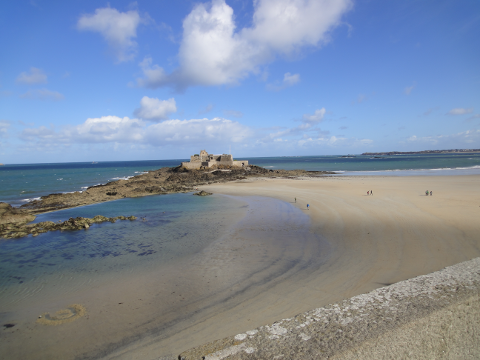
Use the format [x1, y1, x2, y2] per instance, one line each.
[0, 197, 328, 359]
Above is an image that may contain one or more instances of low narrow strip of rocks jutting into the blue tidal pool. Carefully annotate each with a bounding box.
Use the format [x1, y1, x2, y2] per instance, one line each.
[0, 215, 136, 239]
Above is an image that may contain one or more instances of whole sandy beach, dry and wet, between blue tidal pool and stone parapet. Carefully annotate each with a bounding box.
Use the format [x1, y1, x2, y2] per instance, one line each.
[3, 175, 480, 359]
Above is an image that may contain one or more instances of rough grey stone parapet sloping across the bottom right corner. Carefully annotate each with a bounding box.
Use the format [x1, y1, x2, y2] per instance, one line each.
[178, 258, 480, 360]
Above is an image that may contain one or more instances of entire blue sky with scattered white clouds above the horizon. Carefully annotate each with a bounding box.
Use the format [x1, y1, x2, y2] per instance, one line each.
[0, 0, 480, 164]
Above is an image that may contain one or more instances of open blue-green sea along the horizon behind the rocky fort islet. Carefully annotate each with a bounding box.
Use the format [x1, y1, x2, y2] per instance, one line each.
[0, 154, 480, 206]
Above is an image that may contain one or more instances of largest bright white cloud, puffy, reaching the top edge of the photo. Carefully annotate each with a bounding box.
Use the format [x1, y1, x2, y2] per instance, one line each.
[137, 0, 352, 89]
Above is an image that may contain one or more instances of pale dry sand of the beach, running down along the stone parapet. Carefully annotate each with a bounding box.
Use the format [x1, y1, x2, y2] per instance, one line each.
[108, 176, 480, 358]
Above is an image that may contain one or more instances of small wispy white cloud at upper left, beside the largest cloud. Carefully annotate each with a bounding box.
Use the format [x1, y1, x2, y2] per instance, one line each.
[77, 7, 142, 62]
